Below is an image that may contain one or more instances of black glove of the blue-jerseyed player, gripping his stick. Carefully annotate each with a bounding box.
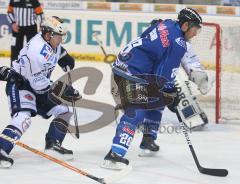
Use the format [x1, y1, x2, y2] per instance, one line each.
[163, 87, 180, 113]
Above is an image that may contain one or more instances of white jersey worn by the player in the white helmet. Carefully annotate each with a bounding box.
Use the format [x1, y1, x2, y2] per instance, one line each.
[13, 33, 62, 93]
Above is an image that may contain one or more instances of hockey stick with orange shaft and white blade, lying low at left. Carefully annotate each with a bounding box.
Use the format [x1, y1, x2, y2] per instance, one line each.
[0, 134, 132, 184]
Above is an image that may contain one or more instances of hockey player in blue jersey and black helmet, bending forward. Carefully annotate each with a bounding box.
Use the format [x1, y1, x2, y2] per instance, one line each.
[102, 8, 202, 169]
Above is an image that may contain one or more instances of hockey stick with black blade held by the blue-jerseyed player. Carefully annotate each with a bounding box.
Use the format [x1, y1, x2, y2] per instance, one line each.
[176, 111, 228, 177]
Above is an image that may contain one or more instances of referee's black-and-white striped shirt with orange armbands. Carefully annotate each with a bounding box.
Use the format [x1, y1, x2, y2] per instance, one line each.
[7, 0, 44, 26]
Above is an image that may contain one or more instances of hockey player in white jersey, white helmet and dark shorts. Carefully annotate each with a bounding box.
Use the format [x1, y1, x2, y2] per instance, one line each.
[0, 16, 80, 167]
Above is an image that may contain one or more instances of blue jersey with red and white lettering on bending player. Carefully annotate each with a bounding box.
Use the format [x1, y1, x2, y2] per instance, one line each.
[113, 19, 186, 88]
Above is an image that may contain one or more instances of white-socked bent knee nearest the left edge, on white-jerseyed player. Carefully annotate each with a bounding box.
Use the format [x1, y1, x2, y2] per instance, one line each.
[10, 111, 31, 133]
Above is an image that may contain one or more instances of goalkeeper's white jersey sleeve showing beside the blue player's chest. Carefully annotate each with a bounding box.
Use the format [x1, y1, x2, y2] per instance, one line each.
[181, 42, 204, 75]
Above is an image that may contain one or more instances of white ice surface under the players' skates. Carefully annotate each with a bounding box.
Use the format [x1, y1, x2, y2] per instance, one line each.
[0, 58, 240, 184]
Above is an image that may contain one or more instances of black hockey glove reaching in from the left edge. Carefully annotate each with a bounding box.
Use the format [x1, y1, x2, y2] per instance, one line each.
[0, 66, 27, 88]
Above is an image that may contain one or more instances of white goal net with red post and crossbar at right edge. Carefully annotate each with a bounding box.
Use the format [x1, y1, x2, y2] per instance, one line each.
[191, 23, 240, 123]
